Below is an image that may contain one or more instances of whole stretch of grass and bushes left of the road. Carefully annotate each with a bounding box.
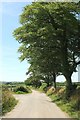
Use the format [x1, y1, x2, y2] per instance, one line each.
[1, 82, 32, 115]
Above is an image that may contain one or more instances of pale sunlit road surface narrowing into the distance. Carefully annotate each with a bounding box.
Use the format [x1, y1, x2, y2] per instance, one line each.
[3, 90, 69, 118]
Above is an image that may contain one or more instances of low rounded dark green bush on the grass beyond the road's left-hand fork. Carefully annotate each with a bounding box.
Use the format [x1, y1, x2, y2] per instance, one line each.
[14, 86, 31, 94]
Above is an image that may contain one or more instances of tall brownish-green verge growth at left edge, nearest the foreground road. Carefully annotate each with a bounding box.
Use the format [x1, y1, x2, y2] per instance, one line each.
[2, 88, 18, 114]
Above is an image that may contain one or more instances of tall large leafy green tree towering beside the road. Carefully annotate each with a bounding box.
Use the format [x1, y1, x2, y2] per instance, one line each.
[14, 3, 80, 96]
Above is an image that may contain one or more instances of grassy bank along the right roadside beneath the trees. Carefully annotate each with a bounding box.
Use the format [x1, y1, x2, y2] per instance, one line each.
[39, 83, 80, 120]
